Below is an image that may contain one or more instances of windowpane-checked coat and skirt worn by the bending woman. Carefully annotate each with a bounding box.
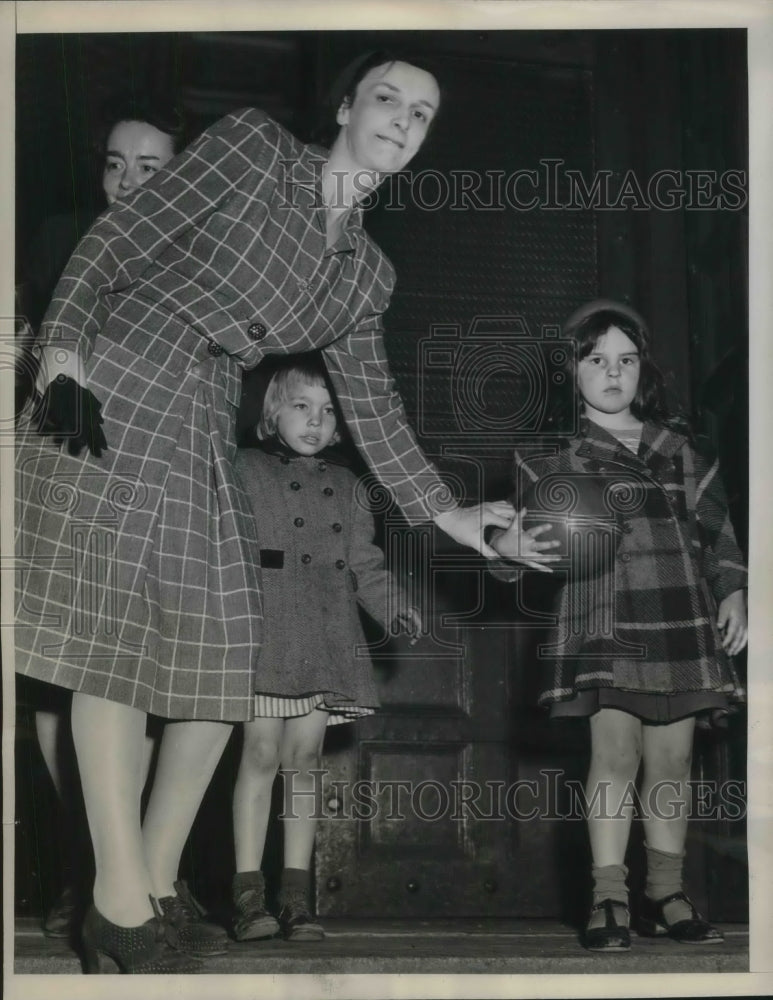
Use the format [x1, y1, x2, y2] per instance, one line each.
[16, 109, 442, 721]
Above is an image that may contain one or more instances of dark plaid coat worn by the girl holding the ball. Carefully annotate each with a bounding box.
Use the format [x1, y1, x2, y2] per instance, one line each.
[496, 420, 746, 703]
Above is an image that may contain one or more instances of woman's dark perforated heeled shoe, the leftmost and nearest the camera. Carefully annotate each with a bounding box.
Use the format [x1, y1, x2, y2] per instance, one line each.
[81, 901, 202, 975]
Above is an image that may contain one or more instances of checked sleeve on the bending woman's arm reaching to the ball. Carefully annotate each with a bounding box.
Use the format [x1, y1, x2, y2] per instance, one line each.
[323, 304, 450, 524]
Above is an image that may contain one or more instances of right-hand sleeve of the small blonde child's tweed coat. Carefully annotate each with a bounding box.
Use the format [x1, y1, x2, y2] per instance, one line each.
[349, 474, 409, 629]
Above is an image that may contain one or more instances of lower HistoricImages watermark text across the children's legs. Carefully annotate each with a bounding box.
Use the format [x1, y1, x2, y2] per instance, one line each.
[280, 768, 746, 823]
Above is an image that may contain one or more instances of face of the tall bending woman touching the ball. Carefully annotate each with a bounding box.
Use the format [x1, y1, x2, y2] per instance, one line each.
[336, 62, 440, 174]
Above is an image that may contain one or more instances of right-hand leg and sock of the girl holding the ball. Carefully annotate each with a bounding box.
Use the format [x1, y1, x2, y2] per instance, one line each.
[641, 717, 695, 923]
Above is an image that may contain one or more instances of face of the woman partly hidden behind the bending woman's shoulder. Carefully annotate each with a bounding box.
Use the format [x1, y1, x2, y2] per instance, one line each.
[102, 122, 174, 205]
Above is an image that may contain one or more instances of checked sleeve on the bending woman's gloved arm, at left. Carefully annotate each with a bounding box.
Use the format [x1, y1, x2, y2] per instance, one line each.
[38, 108, 276, 358]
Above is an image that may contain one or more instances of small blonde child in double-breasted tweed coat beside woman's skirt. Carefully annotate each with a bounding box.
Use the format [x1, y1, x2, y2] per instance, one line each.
[233, 359, 421, 941]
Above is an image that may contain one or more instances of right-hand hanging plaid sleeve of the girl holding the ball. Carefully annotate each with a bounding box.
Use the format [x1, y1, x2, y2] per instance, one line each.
[692, 451, 747, 603]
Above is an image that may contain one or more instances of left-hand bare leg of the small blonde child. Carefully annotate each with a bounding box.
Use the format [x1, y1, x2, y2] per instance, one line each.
[233, 718, 285, 872]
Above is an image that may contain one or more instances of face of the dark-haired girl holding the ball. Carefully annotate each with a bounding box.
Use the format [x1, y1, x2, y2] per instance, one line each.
[577, 326, 641, 427]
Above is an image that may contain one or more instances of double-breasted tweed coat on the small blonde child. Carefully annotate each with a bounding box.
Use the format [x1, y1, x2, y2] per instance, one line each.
[236, 444, 408, 707]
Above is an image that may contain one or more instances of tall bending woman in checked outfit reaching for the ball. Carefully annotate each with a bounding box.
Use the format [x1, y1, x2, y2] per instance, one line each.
[16, 54, 512, 972]
